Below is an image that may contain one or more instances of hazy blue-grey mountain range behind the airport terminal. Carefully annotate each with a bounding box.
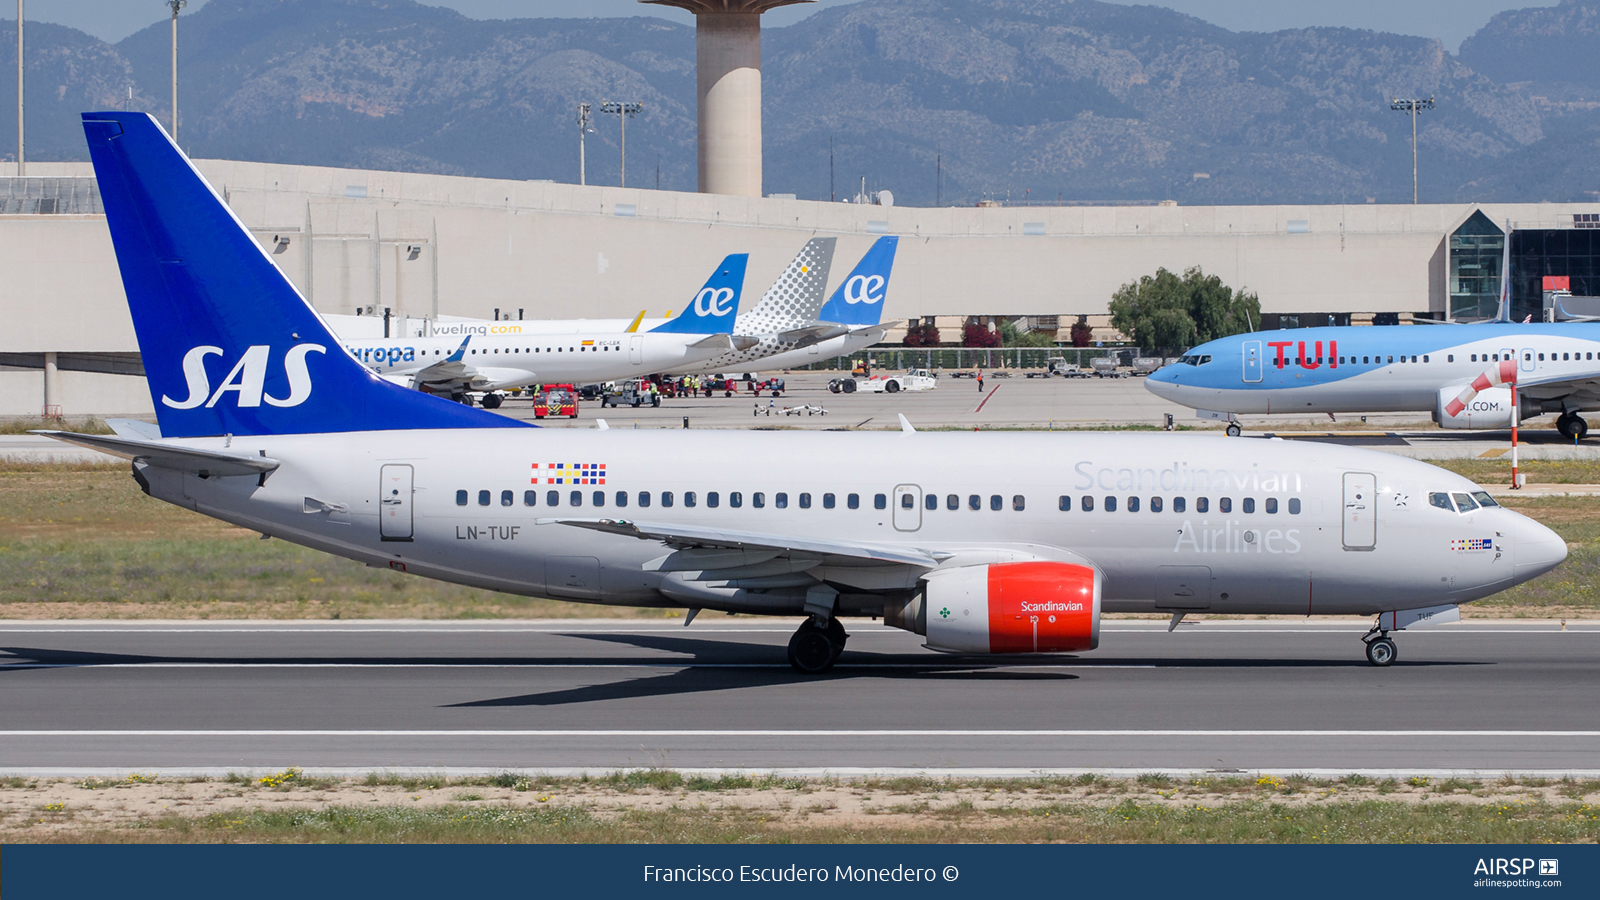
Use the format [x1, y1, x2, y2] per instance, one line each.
[0, 0, 1600, 205]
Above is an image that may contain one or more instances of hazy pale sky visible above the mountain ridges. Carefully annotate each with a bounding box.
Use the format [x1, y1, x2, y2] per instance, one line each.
[15, 0, 1555, 51]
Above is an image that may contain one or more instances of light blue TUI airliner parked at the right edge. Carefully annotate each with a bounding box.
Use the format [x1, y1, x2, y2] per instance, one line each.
[1144, 322, 1600, 439]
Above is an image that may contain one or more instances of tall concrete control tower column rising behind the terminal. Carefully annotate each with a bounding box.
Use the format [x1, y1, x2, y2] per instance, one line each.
[640, 0, 813, 197]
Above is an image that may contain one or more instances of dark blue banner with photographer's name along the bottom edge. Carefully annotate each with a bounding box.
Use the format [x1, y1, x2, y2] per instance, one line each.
[0, 844, 1600, 900]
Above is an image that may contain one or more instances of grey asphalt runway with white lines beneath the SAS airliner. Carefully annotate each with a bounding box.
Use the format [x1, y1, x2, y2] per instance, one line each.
[0, 618, 1600, 773]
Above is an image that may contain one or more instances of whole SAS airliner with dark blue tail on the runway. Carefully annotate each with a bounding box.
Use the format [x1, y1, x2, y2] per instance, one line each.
[46, 112, 1566, 673]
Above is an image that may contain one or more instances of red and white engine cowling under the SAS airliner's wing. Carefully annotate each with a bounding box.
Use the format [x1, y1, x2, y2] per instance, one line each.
[922, 562, 1101, 653]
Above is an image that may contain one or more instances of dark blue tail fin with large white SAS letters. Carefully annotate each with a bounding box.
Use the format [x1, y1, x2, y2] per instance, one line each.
[83, 112, 522, 437]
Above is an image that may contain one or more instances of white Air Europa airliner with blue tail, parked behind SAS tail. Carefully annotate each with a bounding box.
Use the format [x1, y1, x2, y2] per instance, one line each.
[344, 253, 758, 410]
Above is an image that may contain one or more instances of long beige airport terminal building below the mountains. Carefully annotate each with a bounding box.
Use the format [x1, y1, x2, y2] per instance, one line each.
[0, 160, 1600, 416]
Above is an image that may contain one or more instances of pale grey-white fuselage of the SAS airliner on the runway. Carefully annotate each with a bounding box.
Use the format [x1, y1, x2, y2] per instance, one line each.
[141, 429, 1566, 615]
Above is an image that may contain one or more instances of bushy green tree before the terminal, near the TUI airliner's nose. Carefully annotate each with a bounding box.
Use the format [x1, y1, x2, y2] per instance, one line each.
[1110, 266, 1261, 352]
